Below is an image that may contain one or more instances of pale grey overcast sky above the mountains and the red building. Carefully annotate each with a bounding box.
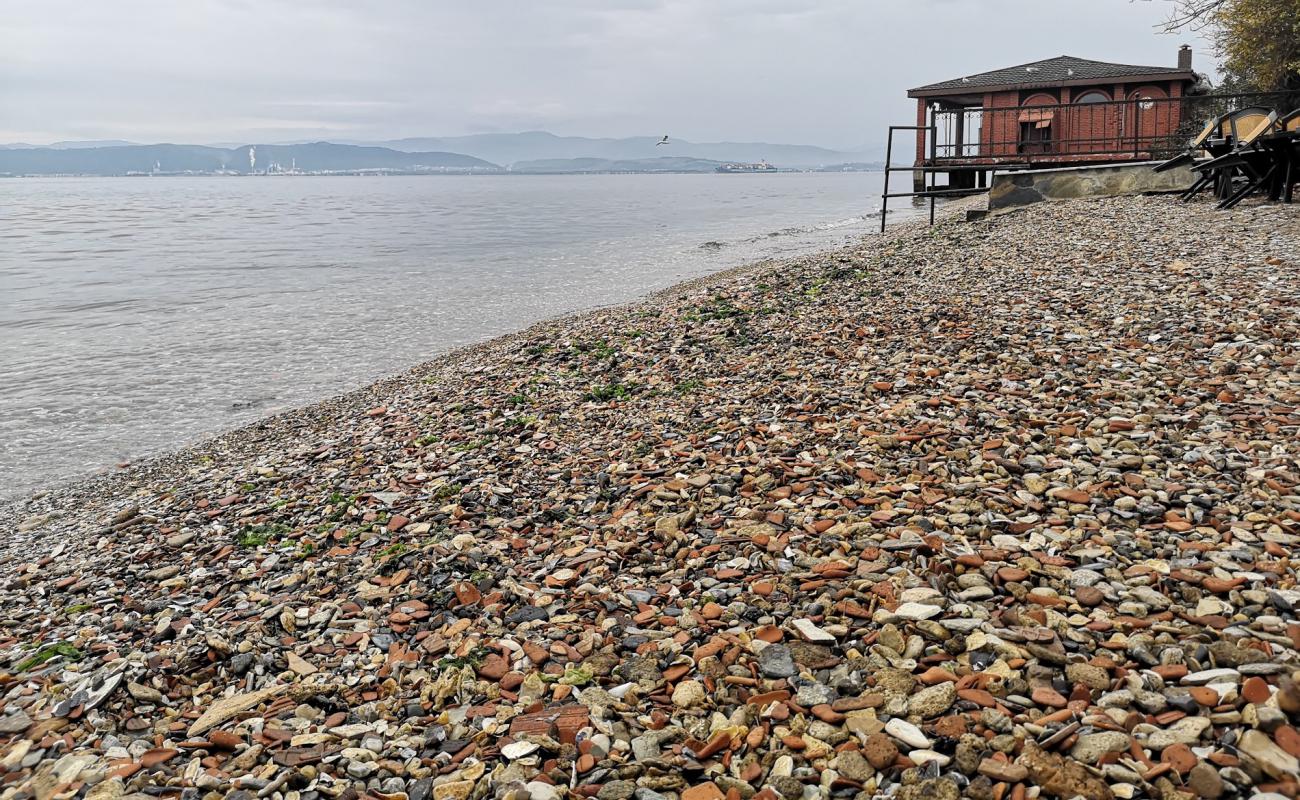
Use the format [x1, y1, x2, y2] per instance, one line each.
[0, 0, 1213, 148]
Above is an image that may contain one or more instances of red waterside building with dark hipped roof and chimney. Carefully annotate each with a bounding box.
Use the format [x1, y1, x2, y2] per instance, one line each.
[907, 46, 1197, 191]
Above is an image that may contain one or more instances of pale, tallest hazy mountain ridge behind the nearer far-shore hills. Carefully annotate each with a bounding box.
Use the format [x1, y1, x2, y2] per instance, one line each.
[358, 131, 863, 167]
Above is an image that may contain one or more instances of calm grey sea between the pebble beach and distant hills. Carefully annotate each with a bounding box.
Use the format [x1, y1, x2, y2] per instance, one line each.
[0, 173, 915, 498]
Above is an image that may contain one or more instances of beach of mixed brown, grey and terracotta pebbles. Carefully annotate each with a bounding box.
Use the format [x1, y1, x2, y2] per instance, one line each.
[0, 196, 1300, 800]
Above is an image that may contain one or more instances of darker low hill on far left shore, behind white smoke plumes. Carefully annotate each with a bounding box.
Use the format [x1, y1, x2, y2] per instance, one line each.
[0, 142, 497, 176]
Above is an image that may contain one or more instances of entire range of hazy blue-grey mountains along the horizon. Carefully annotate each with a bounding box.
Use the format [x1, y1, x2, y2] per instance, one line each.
[0, 131, 872, 176]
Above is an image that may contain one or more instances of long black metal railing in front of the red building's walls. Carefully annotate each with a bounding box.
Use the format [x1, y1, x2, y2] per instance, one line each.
[923, 91, 1297, 167]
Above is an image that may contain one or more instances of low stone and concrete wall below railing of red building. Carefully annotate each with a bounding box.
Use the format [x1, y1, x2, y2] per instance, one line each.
[988, 161, 1195, 211]
